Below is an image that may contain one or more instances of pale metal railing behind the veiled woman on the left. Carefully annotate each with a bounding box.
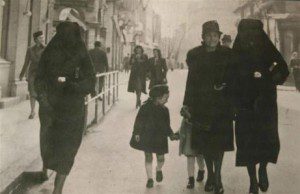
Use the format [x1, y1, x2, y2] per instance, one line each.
[85, 71, 119, 129]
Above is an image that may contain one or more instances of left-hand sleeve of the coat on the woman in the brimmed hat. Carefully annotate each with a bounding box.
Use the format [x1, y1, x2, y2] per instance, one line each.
[183, 52, 194, 107]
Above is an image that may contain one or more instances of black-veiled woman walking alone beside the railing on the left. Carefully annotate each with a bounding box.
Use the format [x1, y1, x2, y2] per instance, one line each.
[35, 22, 95, 194]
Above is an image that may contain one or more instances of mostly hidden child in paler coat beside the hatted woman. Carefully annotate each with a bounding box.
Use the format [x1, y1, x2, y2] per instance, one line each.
[179, 109, 205, 189]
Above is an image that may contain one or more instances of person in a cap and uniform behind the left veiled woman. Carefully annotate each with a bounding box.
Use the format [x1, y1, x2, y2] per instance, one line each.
[19, 31, 45, 119]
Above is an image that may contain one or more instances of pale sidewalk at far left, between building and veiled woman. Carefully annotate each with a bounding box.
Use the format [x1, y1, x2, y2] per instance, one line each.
[0, 100, 40, 191]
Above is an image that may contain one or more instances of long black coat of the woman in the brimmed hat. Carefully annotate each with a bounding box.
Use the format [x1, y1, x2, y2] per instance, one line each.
[183, 45, 233, 153]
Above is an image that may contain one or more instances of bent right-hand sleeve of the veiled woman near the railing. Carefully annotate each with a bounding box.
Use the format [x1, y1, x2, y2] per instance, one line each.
[66, 52, 96, 95]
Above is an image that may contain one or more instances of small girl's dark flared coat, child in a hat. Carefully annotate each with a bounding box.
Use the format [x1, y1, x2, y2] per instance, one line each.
[130, 100, 173, 154]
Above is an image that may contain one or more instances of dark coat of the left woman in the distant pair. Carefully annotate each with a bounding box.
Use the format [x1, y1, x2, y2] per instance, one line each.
[127, 54, 149, 94]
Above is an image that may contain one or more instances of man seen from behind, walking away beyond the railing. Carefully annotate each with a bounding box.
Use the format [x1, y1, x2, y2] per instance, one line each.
[89, 41, 108, 100]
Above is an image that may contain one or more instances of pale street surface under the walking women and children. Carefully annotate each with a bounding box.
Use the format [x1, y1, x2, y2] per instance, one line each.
[27, 70, 300, 194]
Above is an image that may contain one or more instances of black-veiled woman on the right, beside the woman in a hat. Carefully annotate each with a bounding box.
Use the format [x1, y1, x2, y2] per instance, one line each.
[233, 19, 289, 193]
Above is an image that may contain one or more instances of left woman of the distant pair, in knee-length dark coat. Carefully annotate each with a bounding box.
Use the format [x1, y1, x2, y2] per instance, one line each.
[128, 46, 149, 108]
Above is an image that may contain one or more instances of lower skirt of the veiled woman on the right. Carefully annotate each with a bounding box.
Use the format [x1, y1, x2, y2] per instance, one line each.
[235, 110, 280, 166]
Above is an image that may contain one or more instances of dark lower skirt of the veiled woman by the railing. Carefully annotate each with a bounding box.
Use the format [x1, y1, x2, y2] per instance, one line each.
[39, 96, 84, 175]
